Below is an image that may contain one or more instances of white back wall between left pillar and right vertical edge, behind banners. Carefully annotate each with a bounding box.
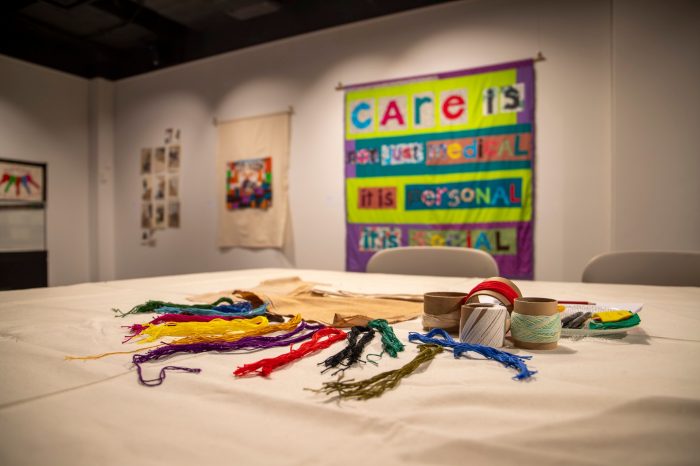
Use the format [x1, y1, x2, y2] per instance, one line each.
[116, 1, 611, 280]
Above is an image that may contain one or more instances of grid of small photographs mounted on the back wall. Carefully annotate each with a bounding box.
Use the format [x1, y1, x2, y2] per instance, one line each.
[141, 138, 181, 235]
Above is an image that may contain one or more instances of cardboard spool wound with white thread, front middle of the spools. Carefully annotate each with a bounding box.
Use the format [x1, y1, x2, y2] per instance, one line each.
[459, 303, 509, 348]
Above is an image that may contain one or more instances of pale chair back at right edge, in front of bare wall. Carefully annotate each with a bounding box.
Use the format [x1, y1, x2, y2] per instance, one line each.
[581, 251, 700, 286]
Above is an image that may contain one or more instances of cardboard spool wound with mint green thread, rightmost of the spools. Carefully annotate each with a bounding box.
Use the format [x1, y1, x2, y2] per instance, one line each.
[510, 298, 561, 350]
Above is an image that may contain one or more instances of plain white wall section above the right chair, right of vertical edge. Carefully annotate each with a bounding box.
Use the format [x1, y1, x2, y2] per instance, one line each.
[612, 0, 700, 250]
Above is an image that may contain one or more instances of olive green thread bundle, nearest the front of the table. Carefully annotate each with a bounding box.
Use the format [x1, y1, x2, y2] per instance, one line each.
[311, 344, 443, 400]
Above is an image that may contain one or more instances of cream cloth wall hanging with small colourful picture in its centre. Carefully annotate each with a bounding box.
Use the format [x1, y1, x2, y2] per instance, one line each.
[216, 112, 290, 248]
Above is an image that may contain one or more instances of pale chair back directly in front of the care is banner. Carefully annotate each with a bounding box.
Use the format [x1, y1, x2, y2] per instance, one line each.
[367, 246, 498, 278]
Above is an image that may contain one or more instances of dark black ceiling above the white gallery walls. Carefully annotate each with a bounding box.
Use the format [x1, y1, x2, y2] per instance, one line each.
[0, 0, 454, 79]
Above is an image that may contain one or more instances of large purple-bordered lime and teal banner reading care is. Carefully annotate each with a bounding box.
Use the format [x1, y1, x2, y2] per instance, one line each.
[345, 60, 535, 279]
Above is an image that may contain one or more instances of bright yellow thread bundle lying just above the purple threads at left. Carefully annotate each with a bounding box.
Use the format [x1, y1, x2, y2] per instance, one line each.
[139, 316, 269, 343]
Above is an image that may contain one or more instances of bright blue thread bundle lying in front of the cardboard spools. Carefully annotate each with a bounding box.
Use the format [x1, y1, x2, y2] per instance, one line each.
[408, 328, 537, 380]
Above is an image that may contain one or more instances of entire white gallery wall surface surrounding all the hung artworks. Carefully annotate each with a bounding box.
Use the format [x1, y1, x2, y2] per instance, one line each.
[0, 0, 700, 285]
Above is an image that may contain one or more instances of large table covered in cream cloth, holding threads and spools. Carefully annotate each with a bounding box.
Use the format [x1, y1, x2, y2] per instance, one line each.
[0, 269, 700, 466]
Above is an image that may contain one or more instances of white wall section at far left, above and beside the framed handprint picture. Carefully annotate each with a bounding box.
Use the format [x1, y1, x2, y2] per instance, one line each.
[0, 56, 90, 286]
